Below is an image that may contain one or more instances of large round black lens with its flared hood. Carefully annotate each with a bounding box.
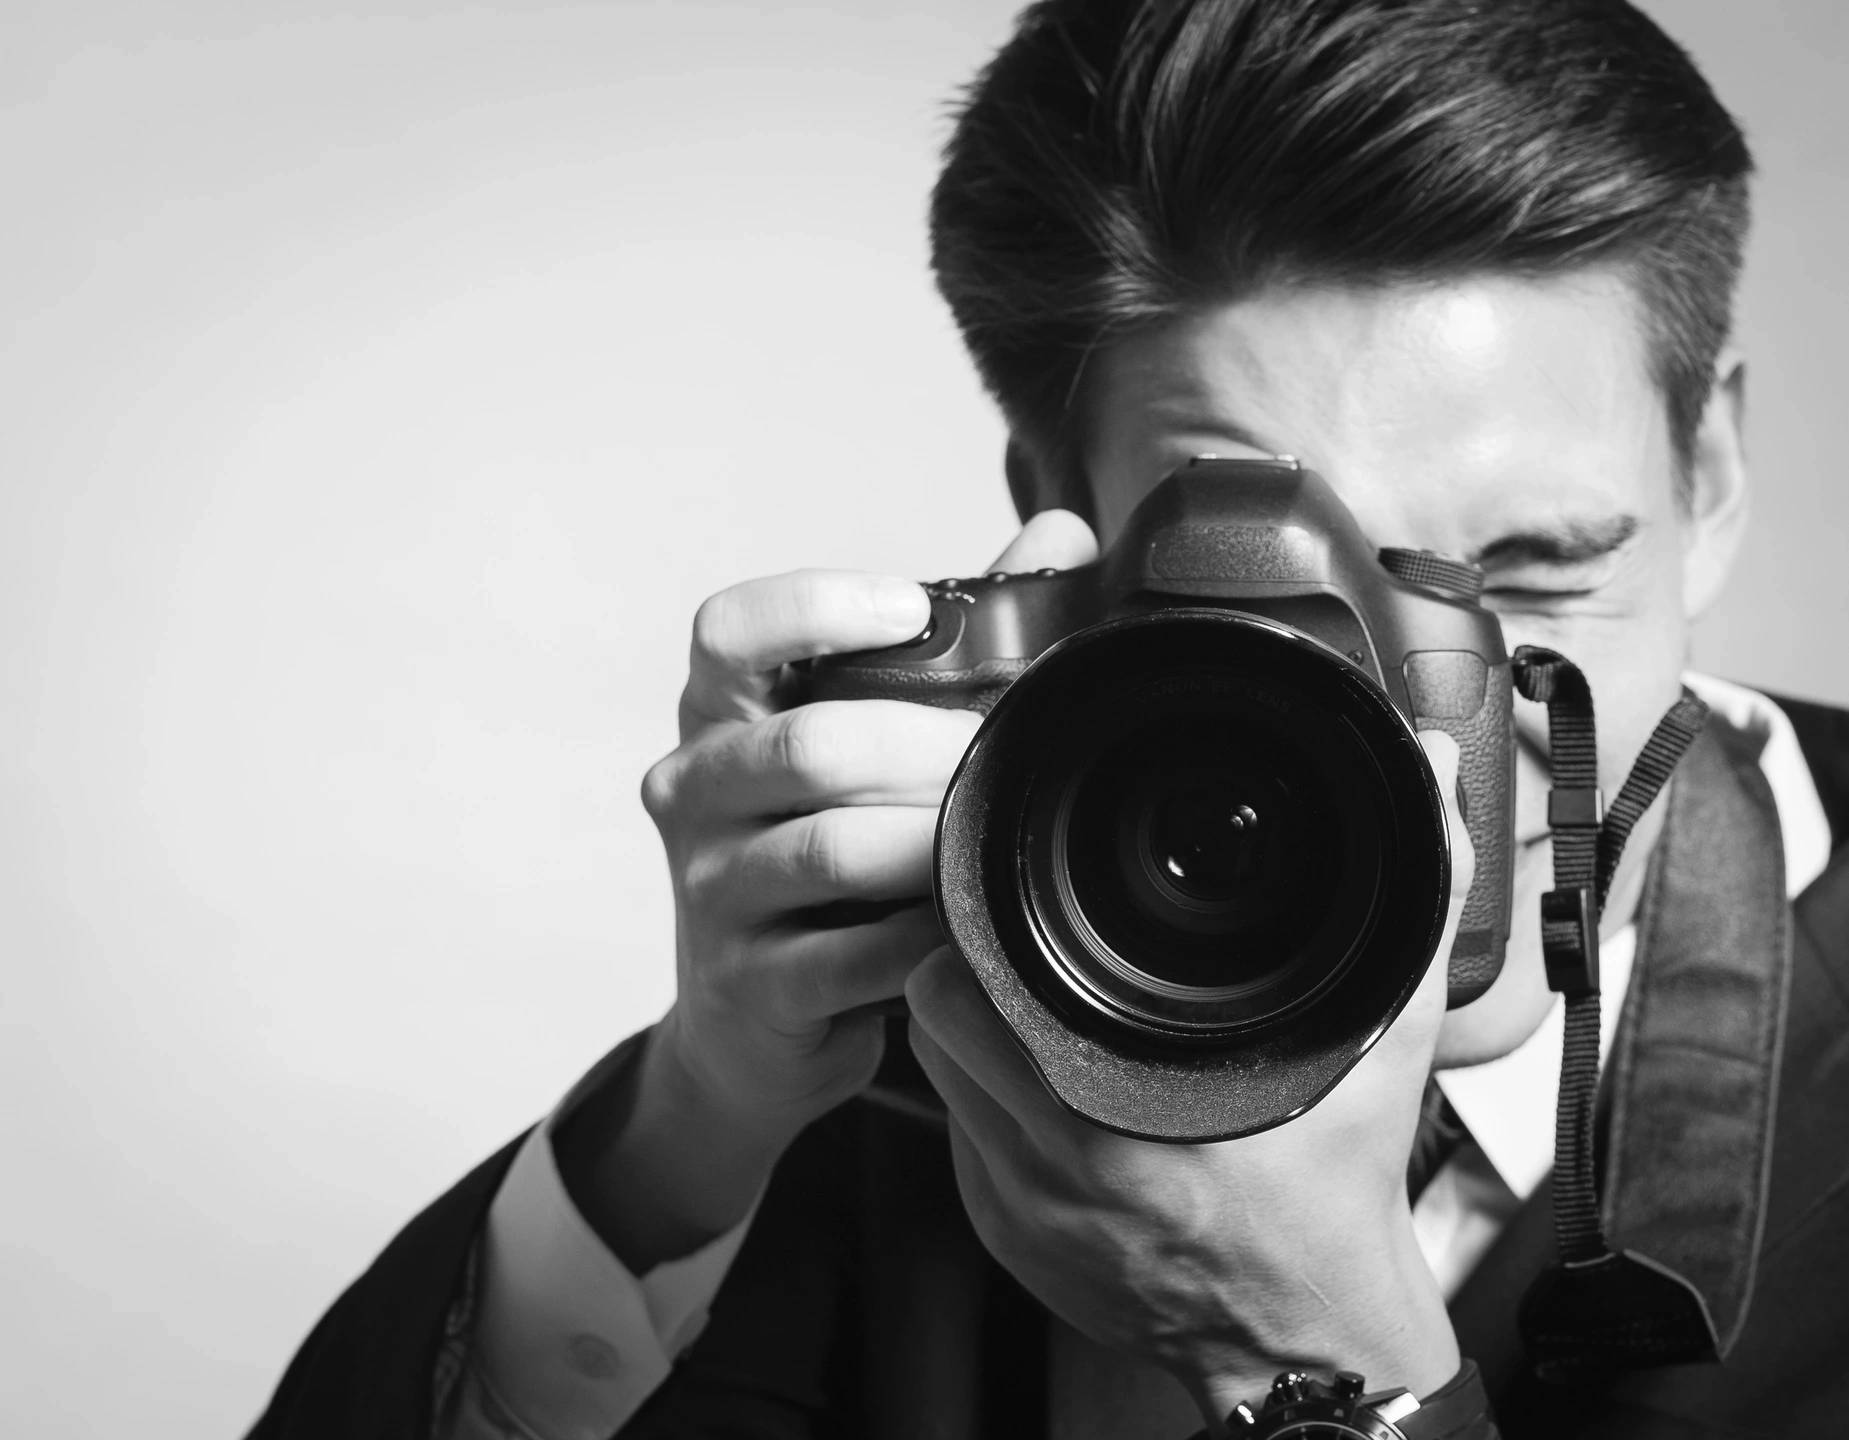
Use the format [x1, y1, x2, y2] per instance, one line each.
[936, 606, 1450, 1141]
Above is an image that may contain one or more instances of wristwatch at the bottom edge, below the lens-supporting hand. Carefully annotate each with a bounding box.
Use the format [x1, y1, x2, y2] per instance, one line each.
[1226, 1361, 1496, 1440]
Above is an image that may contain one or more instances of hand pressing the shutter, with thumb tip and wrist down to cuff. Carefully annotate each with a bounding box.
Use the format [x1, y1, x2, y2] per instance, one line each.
[560, 512, 1096, 1274]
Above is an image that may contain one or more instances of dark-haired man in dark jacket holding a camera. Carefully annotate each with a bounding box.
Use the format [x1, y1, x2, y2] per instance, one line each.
[257, 0, 1849, 1440]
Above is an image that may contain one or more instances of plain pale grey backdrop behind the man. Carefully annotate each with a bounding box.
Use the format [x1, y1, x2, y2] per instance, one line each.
[0, 0, 1849, 1440]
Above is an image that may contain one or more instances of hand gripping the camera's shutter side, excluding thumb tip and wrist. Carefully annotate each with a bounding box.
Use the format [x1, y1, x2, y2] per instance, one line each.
[642, 571, 980, 1135]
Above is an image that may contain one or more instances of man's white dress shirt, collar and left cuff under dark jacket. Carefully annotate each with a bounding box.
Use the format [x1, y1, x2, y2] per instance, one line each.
[447, 675, 1829, 1440]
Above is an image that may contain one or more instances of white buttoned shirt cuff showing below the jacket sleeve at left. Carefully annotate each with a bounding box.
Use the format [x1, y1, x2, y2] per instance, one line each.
[475, 1044, 756, 1440]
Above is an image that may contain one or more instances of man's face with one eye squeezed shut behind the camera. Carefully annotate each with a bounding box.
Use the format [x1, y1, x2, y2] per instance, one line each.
[1078, 272, 1744, 1063]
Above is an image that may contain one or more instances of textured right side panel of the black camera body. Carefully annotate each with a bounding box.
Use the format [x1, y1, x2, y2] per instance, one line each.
[1405, 651, 1514, 1009]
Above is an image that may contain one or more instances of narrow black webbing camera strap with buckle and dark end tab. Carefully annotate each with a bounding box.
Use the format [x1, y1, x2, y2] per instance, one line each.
[1511, 645, 1718, 1379]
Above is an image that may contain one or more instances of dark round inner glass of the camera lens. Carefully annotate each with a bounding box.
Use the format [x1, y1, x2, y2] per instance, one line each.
[1030, 695, 1381, 1020]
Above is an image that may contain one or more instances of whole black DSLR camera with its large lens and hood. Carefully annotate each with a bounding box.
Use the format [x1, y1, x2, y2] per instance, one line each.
[808, 457, 1514, 1141]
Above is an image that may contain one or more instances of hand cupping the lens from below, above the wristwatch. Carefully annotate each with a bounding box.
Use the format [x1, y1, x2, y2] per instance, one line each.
[906, 732, 1474, 1427]
